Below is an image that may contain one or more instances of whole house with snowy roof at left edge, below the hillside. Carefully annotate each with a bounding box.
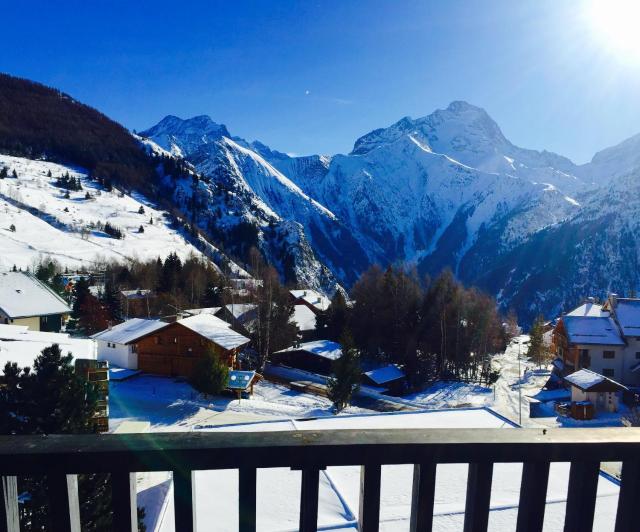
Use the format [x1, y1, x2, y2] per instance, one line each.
[0, 272, 71, 332]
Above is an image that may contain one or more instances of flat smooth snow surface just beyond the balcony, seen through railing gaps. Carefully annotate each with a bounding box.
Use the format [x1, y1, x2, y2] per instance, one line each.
[142, 409, 618, 532]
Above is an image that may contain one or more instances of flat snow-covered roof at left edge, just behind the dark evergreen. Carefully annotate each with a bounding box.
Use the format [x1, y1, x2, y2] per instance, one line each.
[0, 324, 96, 367]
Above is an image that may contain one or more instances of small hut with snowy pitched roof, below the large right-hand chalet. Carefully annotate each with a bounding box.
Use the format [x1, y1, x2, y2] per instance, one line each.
[564, 369, 627, 419]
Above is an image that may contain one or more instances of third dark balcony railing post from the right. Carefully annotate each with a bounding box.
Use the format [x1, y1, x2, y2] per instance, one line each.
[516, 462, 549, 532]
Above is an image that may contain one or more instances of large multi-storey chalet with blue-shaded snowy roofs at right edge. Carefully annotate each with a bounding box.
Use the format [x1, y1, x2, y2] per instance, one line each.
[552, 294, 640, 386]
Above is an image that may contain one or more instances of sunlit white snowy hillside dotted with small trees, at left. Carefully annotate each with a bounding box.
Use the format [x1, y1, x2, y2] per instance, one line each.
[0, 155, 200, 270]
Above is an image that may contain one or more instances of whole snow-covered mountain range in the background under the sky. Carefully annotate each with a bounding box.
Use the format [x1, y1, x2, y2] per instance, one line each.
[143, 101, 640, 319]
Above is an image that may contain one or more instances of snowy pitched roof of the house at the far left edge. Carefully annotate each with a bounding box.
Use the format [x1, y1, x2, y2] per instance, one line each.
[0, 272, 71, 318]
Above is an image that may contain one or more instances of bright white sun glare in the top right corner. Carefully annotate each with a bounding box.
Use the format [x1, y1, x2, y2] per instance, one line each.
[589, 0, 640, 62]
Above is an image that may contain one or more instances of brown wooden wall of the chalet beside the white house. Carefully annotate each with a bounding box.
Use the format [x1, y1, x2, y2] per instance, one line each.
[136, 323, 237, 377]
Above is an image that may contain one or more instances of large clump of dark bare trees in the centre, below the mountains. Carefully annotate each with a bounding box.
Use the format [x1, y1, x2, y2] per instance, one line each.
[319, 266, 509, 388]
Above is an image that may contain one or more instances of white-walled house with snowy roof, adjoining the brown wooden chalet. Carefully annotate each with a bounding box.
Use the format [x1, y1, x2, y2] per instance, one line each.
[91, 318, 167, 370]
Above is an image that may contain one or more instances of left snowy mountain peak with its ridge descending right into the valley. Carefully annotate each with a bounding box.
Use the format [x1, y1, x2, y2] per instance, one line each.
[142, 117, 368, 292]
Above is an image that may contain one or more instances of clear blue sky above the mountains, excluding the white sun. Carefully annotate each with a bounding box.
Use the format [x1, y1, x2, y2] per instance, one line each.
[0, 0, 640, 162]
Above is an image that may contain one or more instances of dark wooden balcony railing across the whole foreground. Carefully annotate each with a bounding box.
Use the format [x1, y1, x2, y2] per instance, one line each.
[0, 428, 640, 532]
